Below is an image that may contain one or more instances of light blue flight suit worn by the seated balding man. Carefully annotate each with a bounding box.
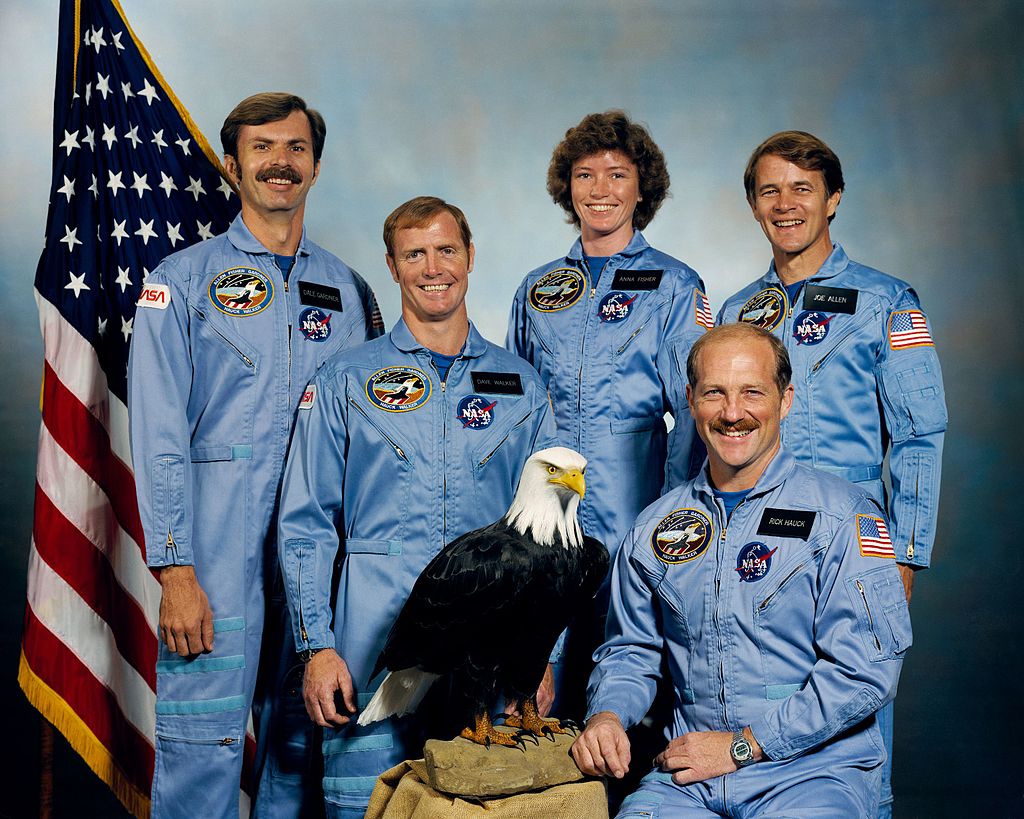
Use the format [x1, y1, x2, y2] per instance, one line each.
[588, 450, 911, 819]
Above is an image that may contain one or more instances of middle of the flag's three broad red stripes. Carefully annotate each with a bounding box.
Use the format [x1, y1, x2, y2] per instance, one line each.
[34, 483, 157, 690]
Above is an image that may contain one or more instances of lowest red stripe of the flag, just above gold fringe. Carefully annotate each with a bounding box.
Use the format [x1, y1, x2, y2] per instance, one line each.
[23, 604, 155, 793]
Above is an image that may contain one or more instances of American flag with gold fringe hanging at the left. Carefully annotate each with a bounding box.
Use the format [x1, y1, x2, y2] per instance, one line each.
[18, 0, 239, 816]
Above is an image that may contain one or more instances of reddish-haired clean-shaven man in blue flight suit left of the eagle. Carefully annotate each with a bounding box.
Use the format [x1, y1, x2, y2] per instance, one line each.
[279, 197, 555, 817]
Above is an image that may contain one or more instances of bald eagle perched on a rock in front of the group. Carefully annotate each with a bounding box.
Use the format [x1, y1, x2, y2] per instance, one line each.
[358, 446, 608, 745]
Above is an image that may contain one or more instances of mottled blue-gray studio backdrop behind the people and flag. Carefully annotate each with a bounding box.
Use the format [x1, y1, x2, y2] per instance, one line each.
[0, 0, 1024, 817]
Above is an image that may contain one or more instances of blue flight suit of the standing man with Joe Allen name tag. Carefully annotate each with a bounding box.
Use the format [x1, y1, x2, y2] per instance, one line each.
[718, 245, 946, 817]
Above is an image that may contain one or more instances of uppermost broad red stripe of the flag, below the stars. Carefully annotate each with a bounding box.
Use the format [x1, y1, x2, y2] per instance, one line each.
[43, 361, 145, 557]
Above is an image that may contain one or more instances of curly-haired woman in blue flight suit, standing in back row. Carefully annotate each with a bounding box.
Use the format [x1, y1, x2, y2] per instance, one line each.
[506, 111, 713, 716]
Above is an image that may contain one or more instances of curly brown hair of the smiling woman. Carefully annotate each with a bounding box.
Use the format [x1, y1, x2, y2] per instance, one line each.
[548, 110, 670, 230]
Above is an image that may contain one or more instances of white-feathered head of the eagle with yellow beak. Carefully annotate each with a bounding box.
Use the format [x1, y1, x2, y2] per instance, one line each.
[505, 446, 587, 549]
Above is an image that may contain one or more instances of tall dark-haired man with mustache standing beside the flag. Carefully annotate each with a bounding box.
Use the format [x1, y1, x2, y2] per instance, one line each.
[129, 93, 383, 819]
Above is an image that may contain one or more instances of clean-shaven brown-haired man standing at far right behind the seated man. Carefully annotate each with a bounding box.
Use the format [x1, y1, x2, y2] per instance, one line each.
[719, 131, 946, 819]
